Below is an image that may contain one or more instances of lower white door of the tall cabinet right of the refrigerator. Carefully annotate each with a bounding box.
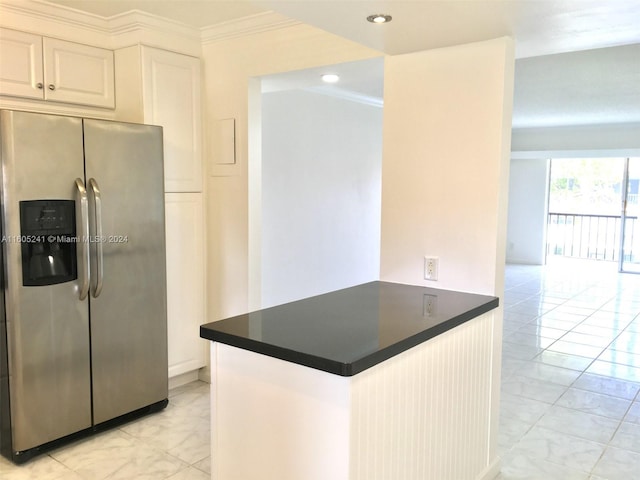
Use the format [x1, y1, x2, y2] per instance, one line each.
[165, 193, 206, 377]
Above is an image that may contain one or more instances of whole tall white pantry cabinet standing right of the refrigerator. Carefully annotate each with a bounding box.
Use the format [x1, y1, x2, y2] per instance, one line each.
[115, 45, 206, 385]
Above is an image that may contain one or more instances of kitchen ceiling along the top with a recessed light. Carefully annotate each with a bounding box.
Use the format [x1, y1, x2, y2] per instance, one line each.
[50, 0, 640, 58]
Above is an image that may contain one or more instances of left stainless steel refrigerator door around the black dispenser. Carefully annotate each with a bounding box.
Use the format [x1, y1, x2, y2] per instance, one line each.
[0, 110, 91, 452]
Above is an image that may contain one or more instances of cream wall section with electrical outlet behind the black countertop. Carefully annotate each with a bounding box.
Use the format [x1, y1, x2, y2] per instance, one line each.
[381, 39, 514, 295]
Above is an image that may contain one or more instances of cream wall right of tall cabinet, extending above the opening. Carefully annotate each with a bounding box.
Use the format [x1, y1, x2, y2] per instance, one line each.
[202, 24, 380, 321]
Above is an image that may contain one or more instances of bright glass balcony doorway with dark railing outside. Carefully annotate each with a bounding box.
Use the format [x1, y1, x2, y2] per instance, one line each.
[546, 158, 640, 273]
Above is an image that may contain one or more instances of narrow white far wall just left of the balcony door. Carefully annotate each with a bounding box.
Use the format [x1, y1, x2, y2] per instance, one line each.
[507, 159, 549, 265]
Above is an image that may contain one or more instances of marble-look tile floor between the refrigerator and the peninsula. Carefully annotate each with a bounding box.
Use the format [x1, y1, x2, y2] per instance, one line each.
[0, 382, 211, 480]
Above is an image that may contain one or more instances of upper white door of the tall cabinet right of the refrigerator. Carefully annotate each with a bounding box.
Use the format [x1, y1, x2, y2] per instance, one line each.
[142, 47, 202, 192]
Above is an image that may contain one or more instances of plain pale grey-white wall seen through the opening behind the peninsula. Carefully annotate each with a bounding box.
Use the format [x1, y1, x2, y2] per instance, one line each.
[262, 90, 382, 307]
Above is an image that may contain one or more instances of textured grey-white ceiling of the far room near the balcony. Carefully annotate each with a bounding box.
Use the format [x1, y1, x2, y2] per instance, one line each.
[513, 43, 640, 128]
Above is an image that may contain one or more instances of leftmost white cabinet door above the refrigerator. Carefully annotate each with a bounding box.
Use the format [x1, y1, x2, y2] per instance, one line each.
[0, 28, 44, 100]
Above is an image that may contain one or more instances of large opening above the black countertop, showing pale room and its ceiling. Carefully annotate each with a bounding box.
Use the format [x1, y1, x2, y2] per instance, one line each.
[249, 57, 384, 308]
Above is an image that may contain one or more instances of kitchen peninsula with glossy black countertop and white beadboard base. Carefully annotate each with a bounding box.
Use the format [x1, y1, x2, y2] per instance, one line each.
[200, 282, 498, 480]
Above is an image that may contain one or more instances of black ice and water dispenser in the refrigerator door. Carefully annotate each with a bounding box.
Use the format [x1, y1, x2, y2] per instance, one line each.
[20, 200, 78, 286]
